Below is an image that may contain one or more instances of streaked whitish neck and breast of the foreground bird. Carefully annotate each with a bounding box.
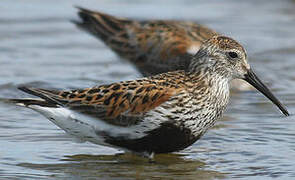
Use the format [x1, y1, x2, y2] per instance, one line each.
[179, 72, 229, 135]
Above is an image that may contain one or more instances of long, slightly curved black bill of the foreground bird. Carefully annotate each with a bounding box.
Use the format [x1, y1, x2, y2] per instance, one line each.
[245, 69, 290, 116]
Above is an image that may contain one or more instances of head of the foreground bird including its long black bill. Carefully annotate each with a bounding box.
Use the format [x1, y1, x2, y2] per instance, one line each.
[189, 36, 289, 115]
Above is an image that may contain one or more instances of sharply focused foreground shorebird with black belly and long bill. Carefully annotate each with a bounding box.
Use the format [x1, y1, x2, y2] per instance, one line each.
[2, 36, 289, 158]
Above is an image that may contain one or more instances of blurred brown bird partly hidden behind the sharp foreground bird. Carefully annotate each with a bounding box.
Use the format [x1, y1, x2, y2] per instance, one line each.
[72, 7, 253, 90]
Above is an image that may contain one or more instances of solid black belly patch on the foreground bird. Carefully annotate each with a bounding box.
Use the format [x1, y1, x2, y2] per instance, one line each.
[97, 123, 201, 153]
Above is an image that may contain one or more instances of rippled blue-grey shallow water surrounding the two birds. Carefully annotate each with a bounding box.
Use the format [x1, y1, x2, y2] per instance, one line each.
[0, 0, 295, 179]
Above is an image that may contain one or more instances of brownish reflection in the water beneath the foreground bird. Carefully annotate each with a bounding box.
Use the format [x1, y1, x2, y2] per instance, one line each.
[18, 153, 226, 179]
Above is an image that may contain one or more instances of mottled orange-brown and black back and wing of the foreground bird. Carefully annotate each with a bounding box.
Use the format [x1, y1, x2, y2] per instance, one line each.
[20, 74, 182, 126]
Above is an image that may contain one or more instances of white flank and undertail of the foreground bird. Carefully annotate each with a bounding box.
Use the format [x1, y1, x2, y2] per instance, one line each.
[29, 105, 163, 146]
